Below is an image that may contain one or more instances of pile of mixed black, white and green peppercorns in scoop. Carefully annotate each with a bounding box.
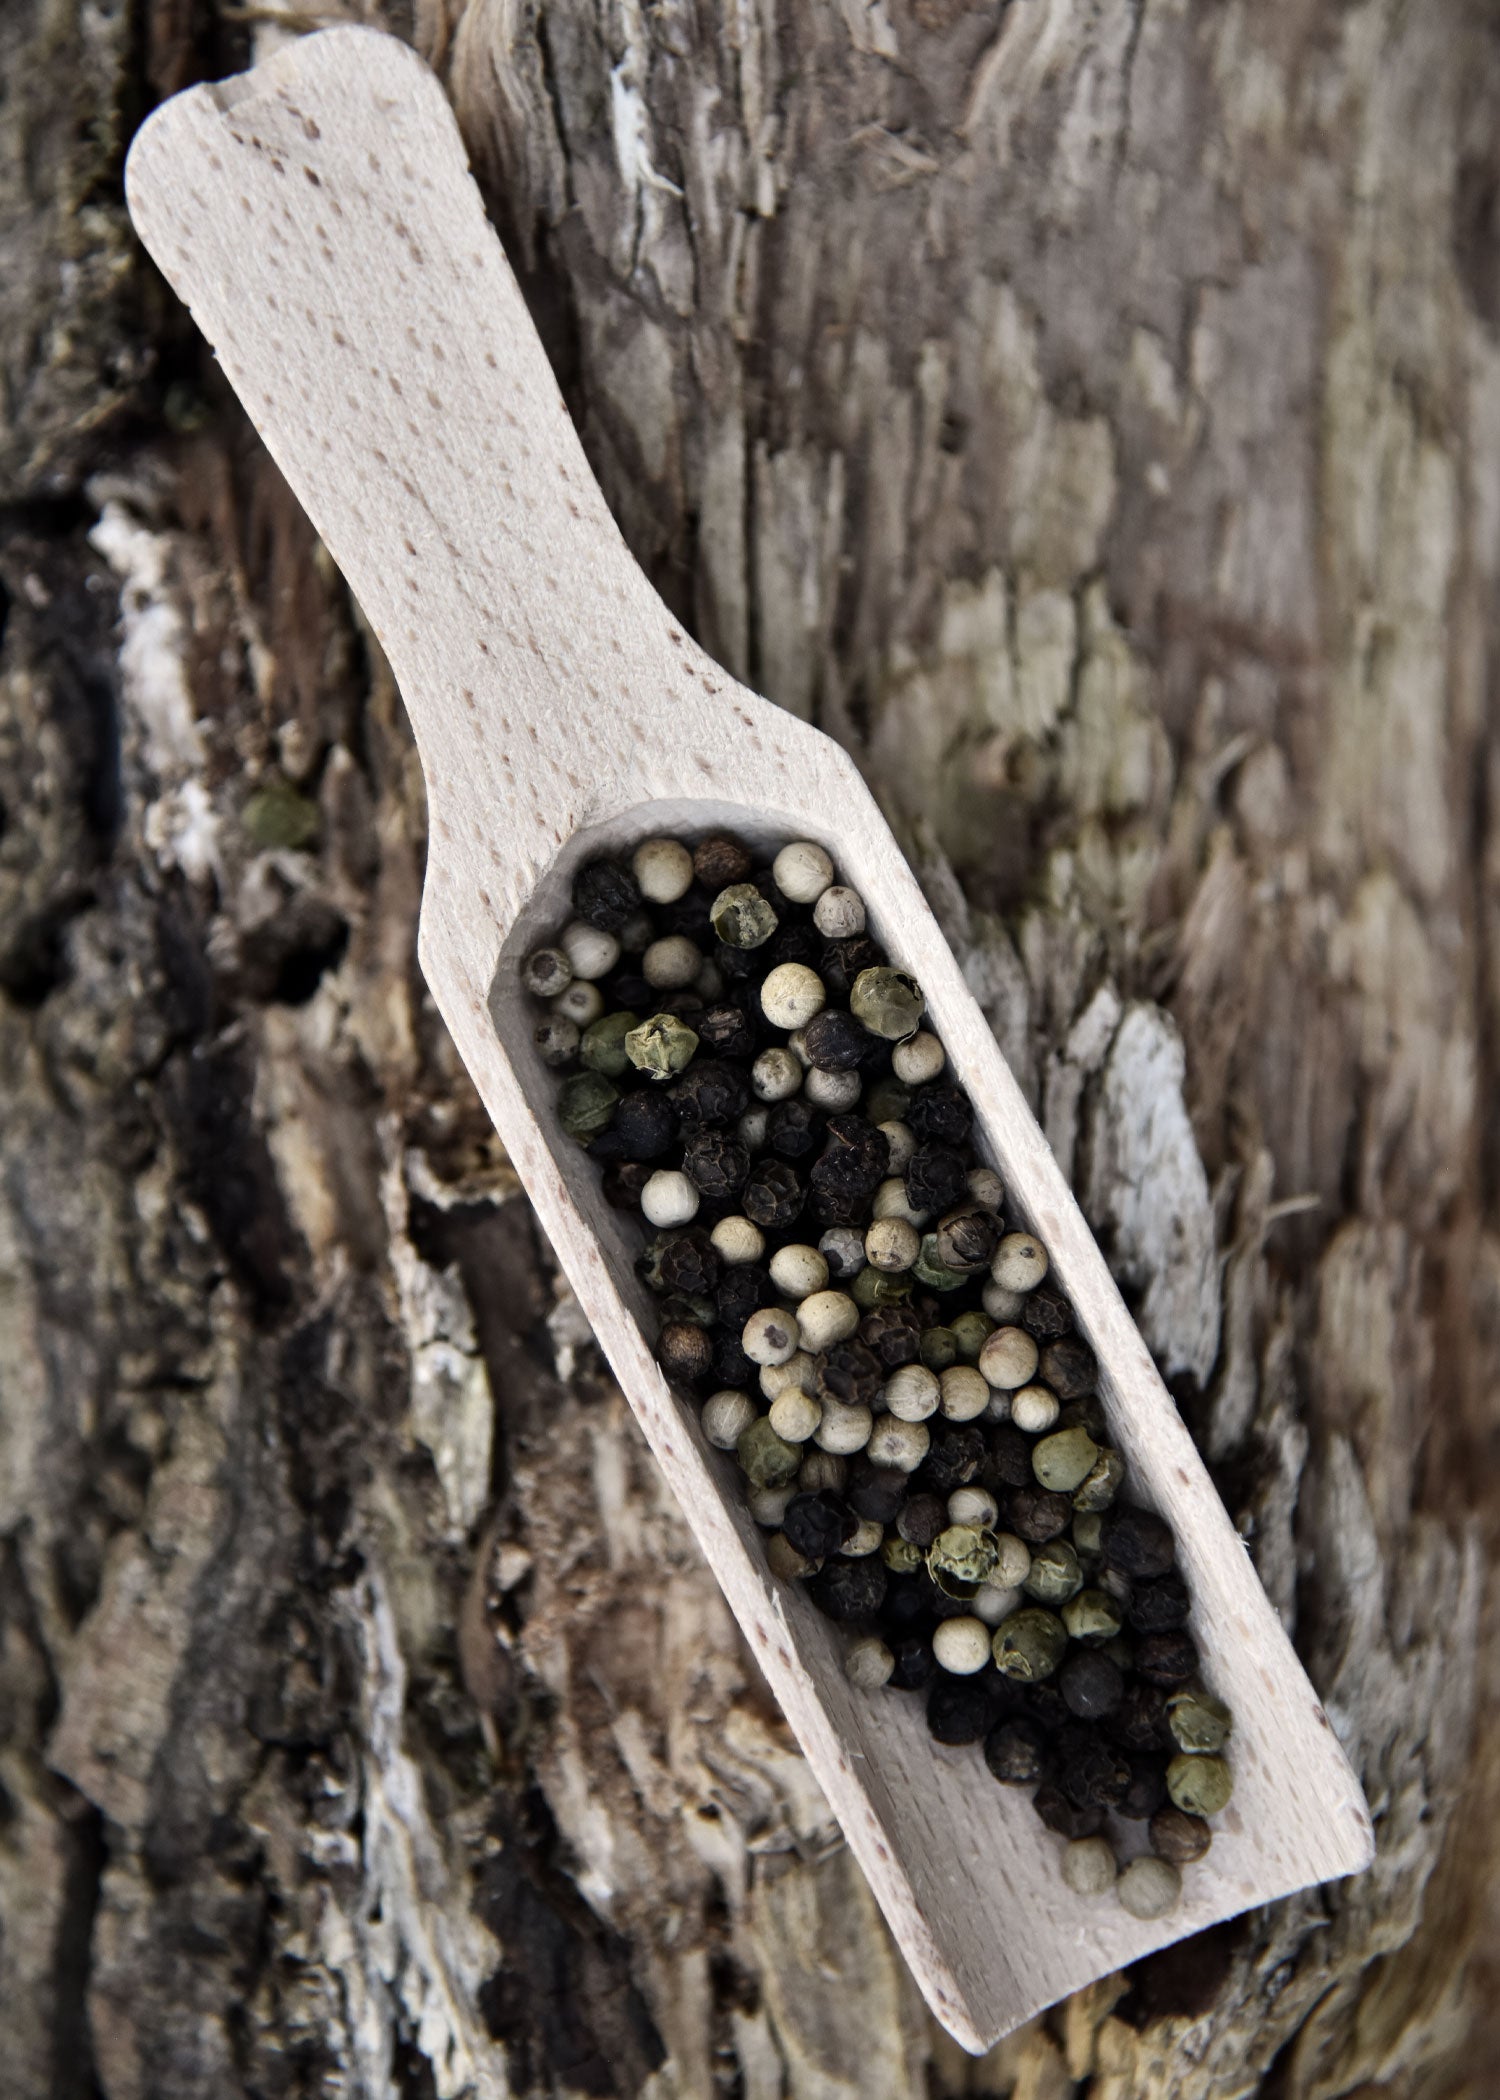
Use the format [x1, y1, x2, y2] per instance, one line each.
[525, 836, 1231, 1917]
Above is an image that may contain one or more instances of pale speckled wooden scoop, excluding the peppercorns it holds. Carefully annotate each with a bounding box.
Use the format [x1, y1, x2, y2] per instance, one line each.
[126, 27, 1372, 2052]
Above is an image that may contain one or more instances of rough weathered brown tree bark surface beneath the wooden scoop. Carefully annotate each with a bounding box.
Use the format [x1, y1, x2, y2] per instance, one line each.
[0, 0, 1500, 2100]
